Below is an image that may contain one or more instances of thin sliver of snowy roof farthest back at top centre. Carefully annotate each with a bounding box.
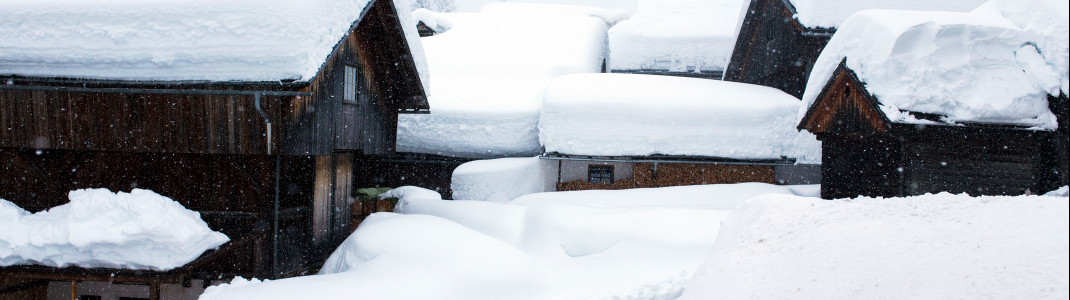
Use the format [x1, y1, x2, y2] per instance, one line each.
[483, 2, 630, 27]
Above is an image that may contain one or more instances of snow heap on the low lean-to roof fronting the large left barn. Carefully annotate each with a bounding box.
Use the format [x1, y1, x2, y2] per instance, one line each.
[0, 189, 230, 271]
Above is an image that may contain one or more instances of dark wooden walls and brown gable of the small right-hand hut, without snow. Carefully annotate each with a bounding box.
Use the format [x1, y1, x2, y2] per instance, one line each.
[798, 62, 1067, 198]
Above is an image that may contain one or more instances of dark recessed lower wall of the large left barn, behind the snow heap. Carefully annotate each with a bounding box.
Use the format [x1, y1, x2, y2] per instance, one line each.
[0, 148, 321, 278]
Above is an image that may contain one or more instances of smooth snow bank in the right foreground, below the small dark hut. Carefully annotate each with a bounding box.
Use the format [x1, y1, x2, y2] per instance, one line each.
[684, 193, 1070, 299]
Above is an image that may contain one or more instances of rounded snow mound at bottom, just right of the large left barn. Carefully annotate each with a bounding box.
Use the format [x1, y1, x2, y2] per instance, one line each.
[200, 213, 546, 300]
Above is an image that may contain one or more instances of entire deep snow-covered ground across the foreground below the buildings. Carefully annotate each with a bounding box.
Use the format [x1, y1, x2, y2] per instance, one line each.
[196, 183, 1070, 299]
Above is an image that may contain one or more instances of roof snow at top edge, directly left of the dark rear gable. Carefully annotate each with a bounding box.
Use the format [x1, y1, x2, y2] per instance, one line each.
[609, 0, 748, 72]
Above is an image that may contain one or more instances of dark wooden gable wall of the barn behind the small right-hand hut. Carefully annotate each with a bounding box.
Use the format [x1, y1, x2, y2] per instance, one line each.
[724, 0, 835, 98]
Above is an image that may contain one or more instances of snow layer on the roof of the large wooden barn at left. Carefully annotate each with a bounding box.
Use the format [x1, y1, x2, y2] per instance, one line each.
[0, 0, 427, 89]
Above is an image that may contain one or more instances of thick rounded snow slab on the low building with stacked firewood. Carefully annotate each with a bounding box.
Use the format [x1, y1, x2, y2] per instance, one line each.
[539, 74, 821, 159]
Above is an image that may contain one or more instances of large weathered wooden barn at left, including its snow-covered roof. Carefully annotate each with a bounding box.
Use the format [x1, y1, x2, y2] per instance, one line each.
[0, 0, 429, 289]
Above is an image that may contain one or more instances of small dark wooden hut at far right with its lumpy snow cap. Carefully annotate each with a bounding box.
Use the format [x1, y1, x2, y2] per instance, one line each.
[798, 10, 1068, 198]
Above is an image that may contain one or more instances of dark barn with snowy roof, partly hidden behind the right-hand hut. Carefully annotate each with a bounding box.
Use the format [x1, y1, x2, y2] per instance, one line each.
[723, 0, 983, 98]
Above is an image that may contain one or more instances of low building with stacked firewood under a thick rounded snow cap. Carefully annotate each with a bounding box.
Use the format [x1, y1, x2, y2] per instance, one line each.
[539, 74, 821, 190]
